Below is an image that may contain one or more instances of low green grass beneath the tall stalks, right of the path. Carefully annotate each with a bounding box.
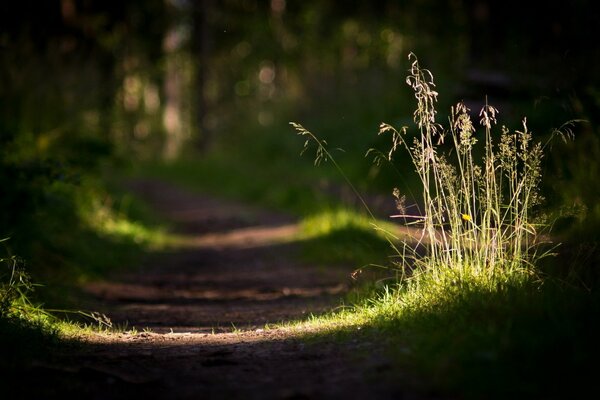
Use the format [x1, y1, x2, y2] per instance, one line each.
[288, 276, 600, 398]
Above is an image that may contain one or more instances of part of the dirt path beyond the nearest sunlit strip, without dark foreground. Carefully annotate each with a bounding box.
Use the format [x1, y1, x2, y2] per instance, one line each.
[82, 180, 349, 333]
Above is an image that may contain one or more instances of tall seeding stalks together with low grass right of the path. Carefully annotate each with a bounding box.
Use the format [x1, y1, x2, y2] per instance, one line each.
[288, 56, 600, 398]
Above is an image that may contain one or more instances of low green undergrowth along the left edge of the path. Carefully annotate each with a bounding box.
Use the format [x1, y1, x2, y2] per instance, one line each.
[0, 172, 172, 371]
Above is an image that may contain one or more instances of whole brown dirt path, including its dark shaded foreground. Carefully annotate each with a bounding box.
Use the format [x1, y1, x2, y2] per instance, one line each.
[14, 180, 426, 399]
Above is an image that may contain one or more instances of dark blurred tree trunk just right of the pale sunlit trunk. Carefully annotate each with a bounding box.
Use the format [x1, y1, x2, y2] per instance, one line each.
[192, 0, 214, 152]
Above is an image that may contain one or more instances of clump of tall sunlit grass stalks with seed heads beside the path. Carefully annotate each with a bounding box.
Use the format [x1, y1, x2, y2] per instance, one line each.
[379, 53, 560, 286]
